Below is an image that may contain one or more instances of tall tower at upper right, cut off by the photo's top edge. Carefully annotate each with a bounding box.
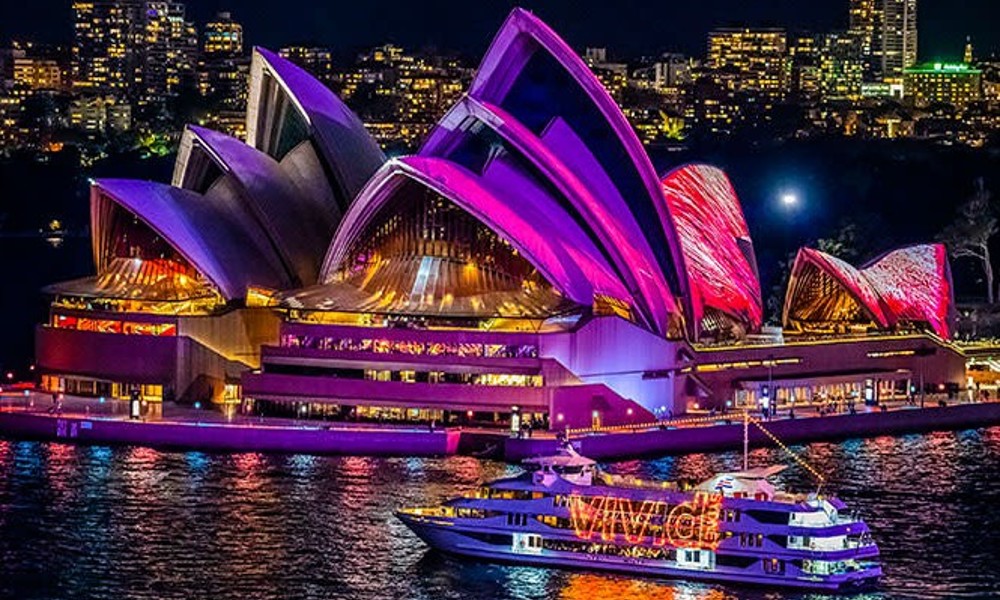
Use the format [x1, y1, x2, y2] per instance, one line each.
[850, 0, 917, 82]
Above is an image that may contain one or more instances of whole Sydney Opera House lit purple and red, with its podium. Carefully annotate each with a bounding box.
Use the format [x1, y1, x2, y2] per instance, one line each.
[36, 10, 964, 428]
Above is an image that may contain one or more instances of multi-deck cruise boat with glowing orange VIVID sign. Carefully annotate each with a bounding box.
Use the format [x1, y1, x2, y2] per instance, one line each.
[396, 445, 882, 591]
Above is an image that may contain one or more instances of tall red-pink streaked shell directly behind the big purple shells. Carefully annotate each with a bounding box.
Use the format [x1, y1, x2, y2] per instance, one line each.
[663, 165, 763, 330]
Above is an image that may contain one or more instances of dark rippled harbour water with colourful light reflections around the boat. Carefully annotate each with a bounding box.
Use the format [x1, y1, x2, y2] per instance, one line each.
[0, 428, 1000, 600]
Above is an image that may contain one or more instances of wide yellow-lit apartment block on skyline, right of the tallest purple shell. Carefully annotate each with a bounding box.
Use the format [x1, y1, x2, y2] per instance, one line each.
[707, 27, 788, 99]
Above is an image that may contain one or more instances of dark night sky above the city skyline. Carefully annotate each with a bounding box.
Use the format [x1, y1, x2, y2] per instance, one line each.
[0, 0, 1000, 59]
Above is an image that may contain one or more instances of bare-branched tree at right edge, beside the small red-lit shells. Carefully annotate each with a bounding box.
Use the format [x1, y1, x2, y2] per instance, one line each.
[938, 177, 1000, 304]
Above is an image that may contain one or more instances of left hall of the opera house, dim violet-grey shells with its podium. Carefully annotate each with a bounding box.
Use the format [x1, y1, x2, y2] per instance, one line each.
[36, 51, 384, 401]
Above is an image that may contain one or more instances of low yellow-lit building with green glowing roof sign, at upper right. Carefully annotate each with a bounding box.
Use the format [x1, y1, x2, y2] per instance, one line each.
[903, 63, 983, 108]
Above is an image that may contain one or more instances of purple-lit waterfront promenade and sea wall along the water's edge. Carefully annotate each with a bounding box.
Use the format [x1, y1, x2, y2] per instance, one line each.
[0, 393, 1000, 462]
